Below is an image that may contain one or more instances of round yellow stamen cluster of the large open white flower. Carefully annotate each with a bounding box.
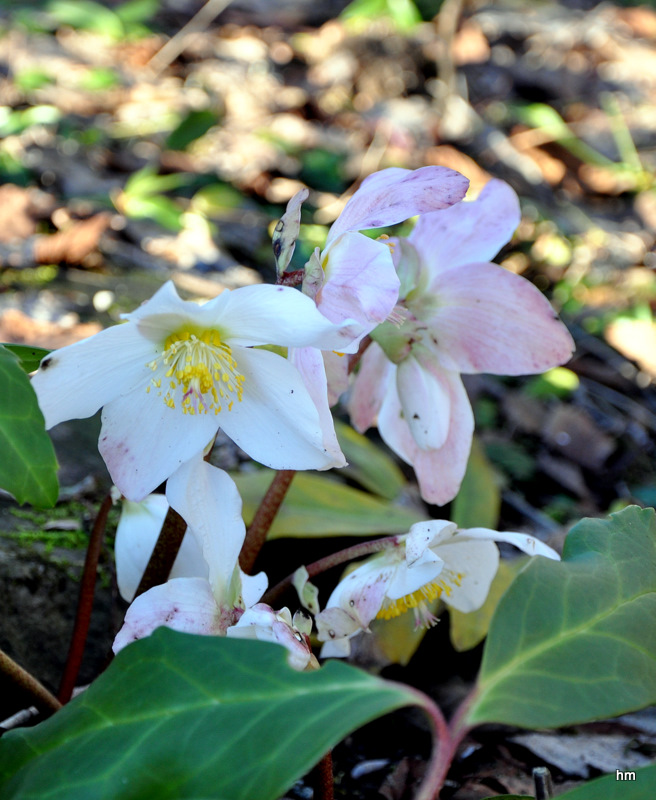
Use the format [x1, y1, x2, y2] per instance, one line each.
[146, 328, 244, 414]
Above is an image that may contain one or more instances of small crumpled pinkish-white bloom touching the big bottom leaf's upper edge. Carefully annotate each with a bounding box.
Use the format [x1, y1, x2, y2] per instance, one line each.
[227, 603, 319, 670]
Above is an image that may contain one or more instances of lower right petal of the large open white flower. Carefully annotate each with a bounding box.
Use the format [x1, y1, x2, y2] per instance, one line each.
[220, 349, 346, 469]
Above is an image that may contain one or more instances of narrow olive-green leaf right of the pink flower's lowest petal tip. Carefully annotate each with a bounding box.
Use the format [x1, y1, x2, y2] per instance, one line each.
[451, 439, 501, 530]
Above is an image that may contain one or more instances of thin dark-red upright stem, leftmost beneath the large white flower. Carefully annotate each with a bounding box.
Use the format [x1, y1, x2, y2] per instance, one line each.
[59, 495, 112, 703]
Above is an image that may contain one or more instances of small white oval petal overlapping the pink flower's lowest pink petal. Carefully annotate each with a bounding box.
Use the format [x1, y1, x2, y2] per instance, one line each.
[396, 356, 451, 450]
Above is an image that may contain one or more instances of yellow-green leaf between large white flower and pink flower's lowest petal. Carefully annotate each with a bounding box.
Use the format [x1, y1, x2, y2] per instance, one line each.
[335, 419, 406, 500]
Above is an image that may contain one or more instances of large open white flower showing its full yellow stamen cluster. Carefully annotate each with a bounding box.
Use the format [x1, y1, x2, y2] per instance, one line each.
[32, 282, 358, 500]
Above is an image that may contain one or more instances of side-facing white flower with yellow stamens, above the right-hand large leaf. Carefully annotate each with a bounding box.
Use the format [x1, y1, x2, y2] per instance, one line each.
[316, 520, 559, 656]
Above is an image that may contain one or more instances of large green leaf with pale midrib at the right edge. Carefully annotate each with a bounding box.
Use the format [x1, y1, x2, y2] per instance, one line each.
[467, 506, 656, 728]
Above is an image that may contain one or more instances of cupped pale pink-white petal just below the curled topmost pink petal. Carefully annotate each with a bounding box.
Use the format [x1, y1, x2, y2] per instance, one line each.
[315, 233, 399, 336]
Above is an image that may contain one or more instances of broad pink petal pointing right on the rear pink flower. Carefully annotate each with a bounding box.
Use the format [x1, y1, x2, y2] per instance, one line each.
[428, 264, 574, 375]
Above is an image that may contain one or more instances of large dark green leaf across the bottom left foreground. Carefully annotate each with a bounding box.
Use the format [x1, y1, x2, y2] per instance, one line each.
[0, 628, 417, 800]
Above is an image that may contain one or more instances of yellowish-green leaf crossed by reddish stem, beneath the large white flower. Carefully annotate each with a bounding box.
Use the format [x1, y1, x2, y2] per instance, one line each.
[232, 469, 423, 539]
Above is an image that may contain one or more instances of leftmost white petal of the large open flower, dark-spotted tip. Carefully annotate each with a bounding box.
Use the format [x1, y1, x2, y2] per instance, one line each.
[32, 324, 155, 428]
